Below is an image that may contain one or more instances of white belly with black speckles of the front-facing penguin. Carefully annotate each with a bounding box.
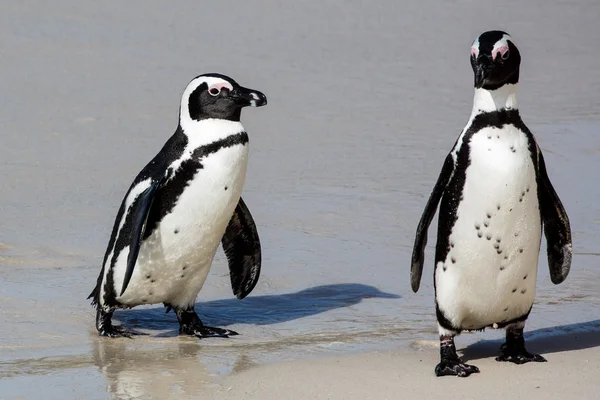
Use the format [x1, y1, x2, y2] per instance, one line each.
[435, 126, 541, 329]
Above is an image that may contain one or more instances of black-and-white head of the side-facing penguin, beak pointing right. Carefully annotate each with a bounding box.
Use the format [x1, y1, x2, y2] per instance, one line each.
[180, 73, 267, 121]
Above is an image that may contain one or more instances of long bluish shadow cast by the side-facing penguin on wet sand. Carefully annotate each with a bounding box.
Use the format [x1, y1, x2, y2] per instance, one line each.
[115, 283, 400, 336]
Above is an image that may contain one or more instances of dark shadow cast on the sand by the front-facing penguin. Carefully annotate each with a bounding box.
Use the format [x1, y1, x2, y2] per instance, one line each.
[462, 319, 600, 362]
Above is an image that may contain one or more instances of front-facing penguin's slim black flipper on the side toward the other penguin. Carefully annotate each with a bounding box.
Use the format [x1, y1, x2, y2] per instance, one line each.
[410, 154, 454, 293]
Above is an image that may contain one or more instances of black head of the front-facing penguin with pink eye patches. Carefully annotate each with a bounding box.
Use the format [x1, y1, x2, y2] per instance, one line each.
[471, 31, 521, 90]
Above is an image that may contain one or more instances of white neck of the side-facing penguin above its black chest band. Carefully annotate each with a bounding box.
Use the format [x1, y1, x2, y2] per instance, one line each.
[179, 118, 244, 148]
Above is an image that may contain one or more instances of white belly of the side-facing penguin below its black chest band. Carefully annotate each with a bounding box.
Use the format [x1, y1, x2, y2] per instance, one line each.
[115, 144, 248, 306]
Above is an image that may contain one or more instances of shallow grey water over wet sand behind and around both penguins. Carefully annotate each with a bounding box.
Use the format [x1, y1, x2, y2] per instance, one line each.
[0, 0, 600, 399]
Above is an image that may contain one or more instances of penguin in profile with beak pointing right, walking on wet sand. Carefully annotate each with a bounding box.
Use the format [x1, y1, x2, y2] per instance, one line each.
[89, 74, 267, 338]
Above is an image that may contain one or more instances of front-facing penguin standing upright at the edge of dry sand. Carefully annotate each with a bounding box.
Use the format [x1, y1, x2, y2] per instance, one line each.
[411, 31, 571, 376]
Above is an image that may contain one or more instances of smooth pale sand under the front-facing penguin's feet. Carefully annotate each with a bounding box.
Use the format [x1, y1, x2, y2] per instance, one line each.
[203, 332, 600, 400]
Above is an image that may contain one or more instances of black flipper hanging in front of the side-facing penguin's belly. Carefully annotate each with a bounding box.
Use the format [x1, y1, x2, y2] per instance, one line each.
[221, 197, 261, 299]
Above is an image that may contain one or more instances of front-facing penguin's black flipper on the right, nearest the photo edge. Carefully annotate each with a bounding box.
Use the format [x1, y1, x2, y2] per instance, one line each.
[538, 148, 573, 285]
